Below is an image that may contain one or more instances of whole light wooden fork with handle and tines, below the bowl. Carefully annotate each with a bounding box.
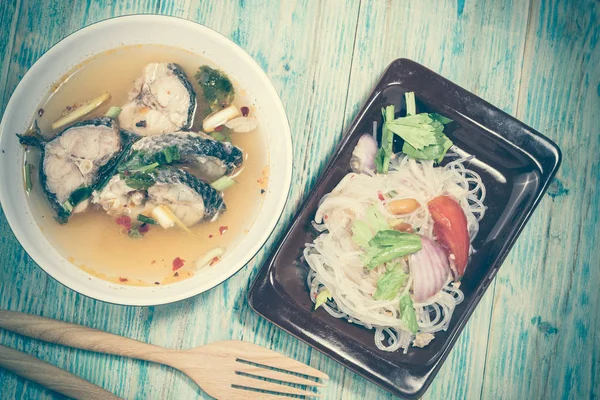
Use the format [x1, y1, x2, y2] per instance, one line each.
[0, 310, 329, 400]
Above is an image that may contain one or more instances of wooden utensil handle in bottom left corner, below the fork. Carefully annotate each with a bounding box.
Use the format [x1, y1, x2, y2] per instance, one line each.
[0, 345, 120, 400]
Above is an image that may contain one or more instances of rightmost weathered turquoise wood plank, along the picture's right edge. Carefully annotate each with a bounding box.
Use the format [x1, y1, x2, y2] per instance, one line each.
[483, 1, 600, 399]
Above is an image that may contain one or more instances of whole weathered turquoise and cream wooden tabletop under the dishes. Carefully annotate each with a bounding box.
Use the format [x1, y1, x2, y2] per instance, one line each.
[0, 0, 600, 399]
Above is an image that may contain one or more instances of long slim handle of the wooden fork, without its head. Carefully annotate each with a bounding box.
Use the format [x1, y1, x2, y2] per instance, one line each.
[0, 310, 175, 364]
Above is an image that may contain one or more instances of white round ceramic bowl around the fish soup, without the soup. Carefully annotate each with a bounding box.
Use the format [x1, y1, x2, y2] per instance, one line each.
[0, 15, 292, 305]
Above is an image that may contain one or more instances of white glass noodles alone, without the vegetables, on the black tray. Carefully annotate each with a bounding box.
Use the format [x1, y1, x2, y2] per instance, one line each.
[304, 156, 485, 352]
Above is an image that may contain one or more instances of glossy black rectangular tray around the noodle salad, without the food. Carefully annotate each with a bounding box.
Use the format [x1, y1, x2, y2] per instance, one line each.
[249, 59, 561, 399]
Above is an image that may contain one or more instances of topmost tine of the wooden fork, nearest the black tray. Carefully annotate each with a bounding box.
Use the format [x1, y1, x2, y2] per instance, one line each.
[236, 342, 329, 380]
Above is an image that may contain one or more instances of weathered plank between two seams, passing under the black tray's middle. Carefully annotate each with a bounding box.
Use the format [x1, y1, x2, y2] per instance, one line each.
[338, 0, 528, 399]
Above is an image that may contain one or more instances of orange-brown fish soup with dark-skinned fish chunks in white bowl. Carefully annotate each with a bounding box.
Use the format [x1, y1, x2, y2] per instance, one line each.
[20, 45, 269, 285]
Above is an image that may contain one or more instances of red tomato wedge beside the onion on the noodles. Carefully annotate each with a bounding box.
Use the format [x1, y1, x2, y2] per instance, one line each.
[427, 196, 470, 278]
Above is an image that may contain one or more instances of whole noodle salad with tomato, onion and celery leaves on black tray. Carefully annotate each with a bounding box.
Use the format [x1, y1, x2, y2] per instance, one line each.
[304, 93, 485, 353]
